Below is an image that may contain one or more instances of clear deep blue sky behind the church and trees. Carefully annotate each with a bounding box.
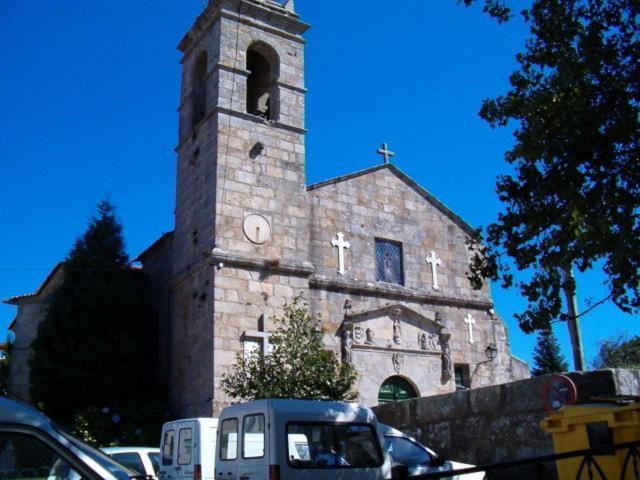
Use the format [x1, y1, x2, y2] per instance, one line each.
[0, 0, 640, 368]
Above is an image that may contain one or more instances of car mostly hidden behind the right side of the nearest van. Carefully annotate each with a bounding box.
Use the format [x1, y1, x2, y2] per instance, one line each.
[379, 423, 485, 480]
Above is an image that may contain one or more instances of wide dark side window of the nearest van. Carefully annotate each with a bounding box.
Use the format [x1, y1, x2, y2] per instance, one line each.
[287, 422, 383, 468]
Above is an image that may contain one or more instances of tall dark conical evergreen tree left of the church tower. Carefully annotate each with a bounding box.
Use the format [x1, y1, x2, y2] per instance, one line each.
[30, 201, 160, 444]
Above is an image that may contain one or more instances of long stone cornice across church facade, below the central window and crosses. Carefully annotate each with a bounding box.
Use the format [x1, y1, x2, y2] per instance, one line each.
[309, 275, 493, 310]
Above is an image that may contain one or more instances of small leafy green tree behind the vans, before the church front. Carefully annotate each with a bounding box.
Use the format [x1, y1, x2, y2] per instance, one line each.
[222, 297, 357, 400]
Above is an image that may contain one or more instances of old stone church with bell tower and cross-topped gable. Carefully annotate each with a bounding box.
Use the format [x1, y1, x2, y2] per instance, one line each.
[2, 0, 529, 416]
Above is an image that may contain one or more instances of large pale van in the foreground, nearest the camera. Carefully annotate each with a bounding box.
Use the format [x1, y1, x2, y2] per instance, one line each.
[215, 400, 391, 480]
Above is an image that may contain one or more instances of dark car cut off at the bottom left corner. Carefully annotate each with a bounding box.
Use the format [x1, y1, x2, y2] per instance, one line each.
[0, 397, 148, 480]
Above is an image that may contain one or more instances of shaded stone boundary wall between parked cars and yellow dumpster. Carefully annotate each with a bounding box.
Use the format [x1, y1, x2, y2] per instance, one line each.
[374, 369, 640, 479]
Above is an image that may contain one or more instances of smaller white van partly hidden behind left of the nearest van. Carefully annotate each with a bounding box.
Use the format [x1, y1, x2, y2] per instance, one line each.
[158, 418, 219, 480]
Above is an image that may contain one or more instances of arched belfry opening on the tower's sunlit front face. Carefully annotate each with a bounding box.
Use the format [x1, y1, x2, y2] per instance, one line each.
[247, 43, 279, 120]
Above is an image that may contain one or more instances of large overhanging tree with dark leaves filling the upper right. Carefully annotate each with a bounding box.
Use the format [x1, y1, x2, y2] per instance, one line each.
[465, 0, 640, 331]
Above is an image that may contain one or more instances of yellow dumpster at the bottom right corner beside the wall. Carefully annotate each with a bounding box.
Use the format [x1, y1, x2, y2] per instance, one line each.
[540, 403, 640, 480]
